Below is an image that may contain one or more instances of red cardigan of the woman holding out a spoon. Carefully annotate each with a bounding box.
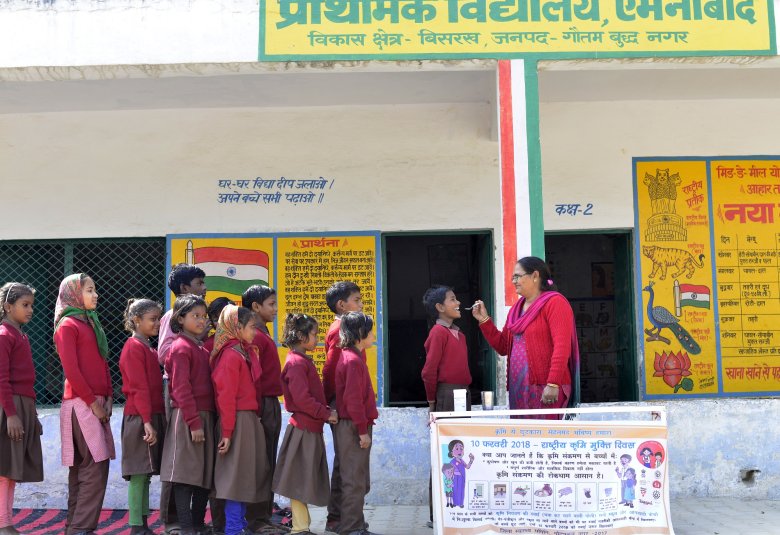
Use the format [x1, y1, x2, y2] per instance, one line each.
[479, 296, 574, 385]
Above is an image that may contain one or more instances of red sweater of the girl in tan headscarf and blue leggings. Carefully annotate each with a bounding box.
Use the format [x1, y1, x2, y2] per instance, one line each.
[211, 345, 259, 438]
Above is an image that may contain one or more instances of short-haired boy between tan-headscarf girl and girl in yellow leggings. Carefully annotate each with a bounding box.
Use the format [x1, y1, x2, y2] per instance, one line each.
[241, 285, 286, 535]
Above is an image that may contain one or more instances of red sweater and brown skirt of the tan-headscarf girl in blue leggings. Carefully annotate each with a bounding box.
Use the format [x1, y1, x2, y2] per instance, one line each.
[212, 341, 269, 506]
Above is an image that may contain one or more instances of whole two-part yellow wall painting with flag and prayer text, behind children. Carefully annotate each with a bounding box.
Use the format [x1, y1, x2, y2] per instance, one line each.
[167, 232, 383, 403]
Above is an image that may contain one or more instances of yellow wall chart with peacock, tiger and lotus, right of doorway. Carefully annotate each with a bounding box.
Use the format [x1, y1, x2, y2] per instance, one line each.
[634, 157, 780, 397]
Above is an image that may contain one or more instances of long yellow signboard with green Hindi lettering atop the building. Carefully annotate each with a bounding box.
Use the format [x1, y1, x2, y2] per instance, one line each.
[259, 0, 775, 61]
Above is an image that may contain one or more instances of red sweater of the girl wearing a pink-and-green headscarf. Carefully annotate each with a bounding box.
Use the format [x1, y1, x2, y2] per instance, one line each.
[54, 316, 113, 405]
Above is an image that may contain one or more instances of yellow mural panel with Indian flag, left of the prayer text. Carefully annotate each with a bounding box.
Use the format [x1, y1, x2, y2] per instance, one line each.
[168, 236, 274, 303]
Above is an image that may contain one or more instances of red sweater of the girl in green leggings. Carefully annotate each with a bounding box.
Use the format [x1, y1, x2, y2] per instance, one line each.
[119, 336, 165, 423]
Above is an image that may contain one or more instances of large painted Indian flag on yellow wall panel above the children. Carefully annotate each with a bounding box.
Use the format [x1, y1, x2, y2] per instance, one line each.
[193, 247, 268, 295]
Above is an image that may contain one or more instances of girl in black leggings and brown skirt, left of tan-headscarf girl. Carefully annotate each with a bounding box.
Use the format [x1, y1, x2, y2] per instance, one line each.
[160, 295, 215, 535]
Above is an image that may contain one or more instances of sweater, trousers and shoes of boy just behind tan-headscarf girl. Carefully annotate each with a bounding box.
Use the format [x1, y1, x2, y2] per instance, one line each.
[246, 325, 282, 530]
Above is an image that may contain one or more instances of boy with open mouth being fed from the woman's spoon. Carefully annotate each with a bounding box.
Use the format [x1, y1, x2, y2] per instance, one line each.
[422, 286, 471, 412]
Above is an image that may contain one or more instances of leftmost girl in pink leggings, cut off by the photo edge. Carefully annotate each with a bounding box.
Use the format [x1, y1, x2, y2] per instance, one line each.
[0, 282, 43, 534]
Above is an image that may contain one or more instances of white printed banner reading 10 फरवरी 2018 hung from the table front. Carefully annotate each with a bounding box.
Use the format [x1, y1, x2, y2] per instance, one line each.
[431, 407, 674, 535]
